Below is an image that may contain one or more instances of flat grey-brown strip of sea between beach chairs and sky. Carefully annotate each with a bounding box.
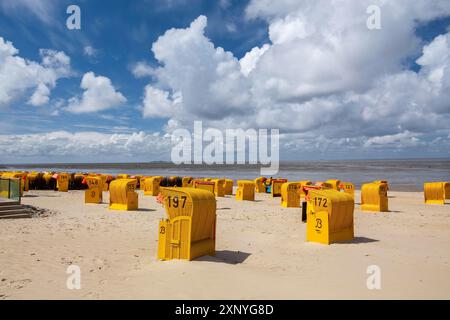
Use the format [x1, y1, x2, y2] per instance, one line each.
[0, 158, 450, 191]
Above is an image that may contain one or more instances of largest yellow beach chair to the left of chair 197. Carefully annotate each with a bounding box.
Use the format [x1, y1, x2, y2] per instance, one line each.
[109, 179, 138, 210]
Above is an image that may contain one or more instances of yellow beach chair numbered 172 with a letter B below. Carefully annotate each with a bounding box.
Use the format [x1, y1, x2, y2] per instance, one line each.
[306, 189, 355, 244]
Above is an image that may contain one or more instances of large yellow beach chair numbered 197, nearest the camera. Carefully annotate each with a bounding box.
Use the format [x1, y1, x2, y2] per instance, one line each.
[158, 188, 216, 260]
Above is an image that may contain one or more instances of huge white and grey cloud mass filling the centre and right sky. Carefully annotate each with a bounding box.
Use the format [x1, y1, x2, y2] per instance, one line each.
[143, 0, 450, 155]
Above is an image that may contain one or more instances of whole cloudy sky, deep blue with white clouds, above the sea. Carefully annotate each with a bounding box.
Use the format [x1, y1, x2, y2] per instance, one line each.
[0, 0, 450, 162]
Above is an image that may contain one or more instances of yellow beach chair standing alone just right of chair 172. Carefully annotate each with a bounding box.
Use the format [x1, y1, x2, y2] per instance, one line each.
[361, 183, 389, 212]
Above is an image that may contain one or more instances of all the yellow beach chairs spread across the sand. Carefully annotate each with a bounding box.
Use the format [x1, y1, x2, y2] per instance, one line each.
[0, 172, 450, 260]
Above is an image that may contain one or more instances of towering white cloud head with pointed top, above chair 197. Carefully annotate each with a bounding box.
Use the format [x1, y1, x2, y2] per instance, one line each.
[144, 16, 250, 122]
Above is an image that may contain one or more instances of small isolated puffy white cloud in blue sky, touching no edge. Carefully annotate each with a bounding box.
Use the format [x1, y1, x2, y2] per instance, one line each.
[67, 72, 127, 113]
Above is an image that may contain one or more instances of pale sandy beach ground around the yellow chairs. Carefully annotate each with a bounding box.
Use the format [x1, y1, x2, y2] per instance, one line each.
[0, 191, 450, 299]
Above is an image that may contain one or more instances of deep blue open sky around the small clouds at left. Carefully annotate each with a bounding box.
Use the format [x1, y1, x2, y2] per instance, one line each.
[0, 0, 267, 134]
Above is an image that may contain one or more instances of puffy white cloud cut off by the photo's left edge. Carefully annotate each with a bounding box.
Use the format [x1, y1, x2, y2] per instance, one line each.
[0, 37, 71, 106]
